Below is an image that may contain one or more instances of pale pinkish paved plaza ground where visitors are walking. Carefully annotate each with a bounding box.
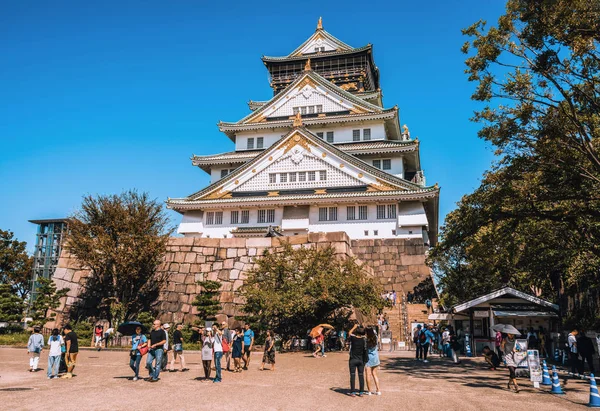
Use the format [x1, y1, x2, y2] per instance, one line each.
[0, 348, 589, 411]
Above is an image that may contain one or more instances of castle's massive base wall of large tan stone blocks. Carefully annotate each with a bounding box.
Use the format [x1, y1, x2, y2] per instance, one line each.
[53, 232, 429, 334]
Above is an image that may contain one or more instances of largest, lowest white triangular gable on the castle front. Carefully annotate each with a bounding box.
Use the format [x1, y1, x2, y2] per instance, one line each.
[187, 127, 422, 200]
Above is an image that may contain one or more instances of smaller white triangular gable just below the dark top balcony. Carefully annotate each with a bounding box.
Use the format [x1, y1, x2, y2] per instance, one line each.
[232, 68, 383, 124]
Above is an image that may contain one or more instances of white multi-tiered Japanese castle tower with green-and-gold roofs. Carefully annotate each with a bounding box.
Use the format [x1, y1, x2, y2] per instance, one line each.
[167, 19, 440, 244]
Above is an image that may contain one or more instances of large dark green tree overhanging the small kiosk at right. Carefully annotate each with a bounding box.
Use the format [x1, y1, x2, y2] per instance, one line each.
[429, 0, 600, 324]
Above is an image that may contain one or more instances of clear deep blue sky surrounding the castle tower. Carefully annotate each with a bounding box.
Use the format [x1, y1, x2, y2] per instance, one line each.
[0, 0, 504, 249]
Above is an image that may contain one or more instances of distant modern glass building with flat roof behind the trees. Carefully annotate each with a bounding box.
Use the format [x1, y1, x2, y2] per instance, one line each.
[29, 218, 68, 301]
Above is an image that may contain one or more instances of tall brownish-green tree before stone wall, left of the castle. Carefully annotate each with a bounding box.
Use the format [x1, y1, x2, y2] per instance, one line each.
[66, 191, 173, 323]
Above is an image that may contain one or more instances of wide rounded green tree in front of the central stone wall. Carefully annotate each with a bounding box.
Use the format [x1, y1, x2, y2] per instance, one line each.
[240, 243, 385, 339]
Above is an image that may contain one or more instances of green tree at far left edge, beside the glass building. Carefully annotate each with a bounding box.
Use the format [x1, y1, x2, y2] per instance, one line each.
[0, 230, 33, 300]
